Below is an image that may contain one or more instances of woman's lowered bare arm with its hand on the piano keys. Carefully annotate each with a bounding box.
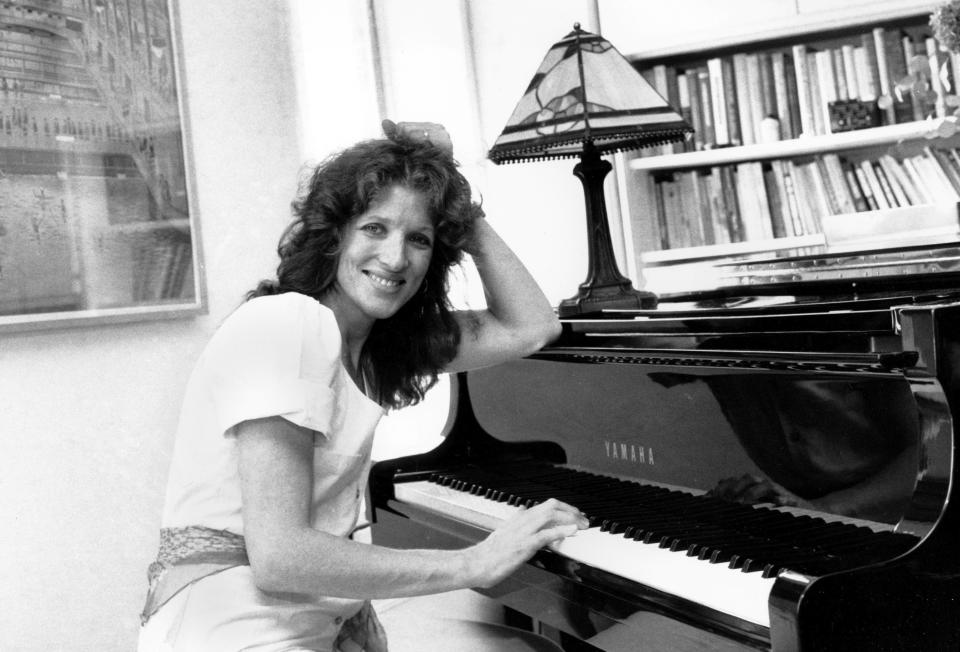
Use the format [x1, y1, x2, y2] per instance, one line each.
[237, 417, 586, 599]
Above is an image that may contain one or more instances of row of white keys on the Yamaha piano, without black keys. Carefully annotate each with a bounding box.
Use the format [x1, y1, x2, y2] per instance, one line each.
[394, 481, 775, 627]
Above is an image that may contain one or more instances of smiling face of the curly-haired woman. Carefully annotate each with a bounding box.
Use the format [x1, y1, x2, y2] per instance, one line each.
[329, 186, 434, 328]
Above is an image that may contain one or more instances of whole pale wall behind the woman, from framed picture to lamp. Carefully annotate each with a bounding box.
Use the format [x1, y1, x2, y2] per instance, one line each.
[0, 0, 628, 652]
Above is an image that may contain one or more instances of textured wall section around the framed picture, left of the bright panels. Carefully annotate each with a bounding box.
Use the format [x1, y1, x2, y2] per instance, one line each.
[0, 0, 302, 652]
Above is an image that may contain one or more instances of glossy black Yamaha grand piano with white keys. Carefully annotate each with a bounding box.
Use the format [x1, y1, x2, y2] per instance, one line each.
[369, 243, 960, 652]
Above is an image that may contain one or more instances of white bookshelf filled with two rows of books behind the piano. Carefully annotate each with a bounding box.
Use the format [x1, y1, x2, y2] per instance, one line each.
[618, 3, 960, 292]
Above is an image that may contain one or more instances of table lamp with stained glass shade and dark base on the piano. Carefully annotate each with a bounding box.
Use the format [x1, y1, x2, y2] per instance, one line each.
[488, 23, 693, 317]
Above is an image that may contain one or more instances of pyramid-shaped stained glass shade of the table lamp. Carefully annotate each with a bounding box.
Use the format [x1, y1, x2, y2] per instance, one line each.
[488, 24, 693, 163]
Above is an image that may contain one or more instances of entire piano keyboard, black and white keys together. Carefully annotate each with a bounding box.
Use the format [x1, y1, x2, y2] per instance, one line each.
[394, 465, 915, 627]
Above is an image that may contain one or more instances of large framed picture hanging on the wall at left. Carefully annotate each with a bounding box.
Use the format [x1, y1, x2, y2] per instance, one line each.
[0, 0, 204, 330]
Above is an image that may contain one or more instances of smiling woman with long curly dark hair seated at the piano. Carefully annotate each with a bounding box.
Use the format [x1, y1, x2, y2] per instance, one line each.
[140, 122, 587, 651]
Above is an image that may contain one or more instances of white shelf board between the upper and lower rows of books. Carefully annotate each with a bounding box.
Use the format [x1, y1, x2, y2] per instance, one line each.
[629, 117, 958, 172]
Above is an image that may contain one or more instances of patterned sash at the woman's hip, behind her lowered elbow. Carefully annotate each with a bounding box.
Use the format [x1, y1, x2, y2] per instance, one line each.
[140, 525, 250, 624]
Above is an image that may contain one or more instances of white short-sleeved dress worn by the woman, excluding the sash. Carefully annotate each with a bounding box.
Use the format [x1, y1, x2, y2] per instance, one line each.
[140, 292, 383, 652]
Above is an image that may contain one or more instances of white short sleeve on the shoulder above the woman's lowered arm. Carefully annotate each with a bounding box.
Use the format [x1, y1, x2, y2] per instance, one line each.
[202, 293, 342, 433]
